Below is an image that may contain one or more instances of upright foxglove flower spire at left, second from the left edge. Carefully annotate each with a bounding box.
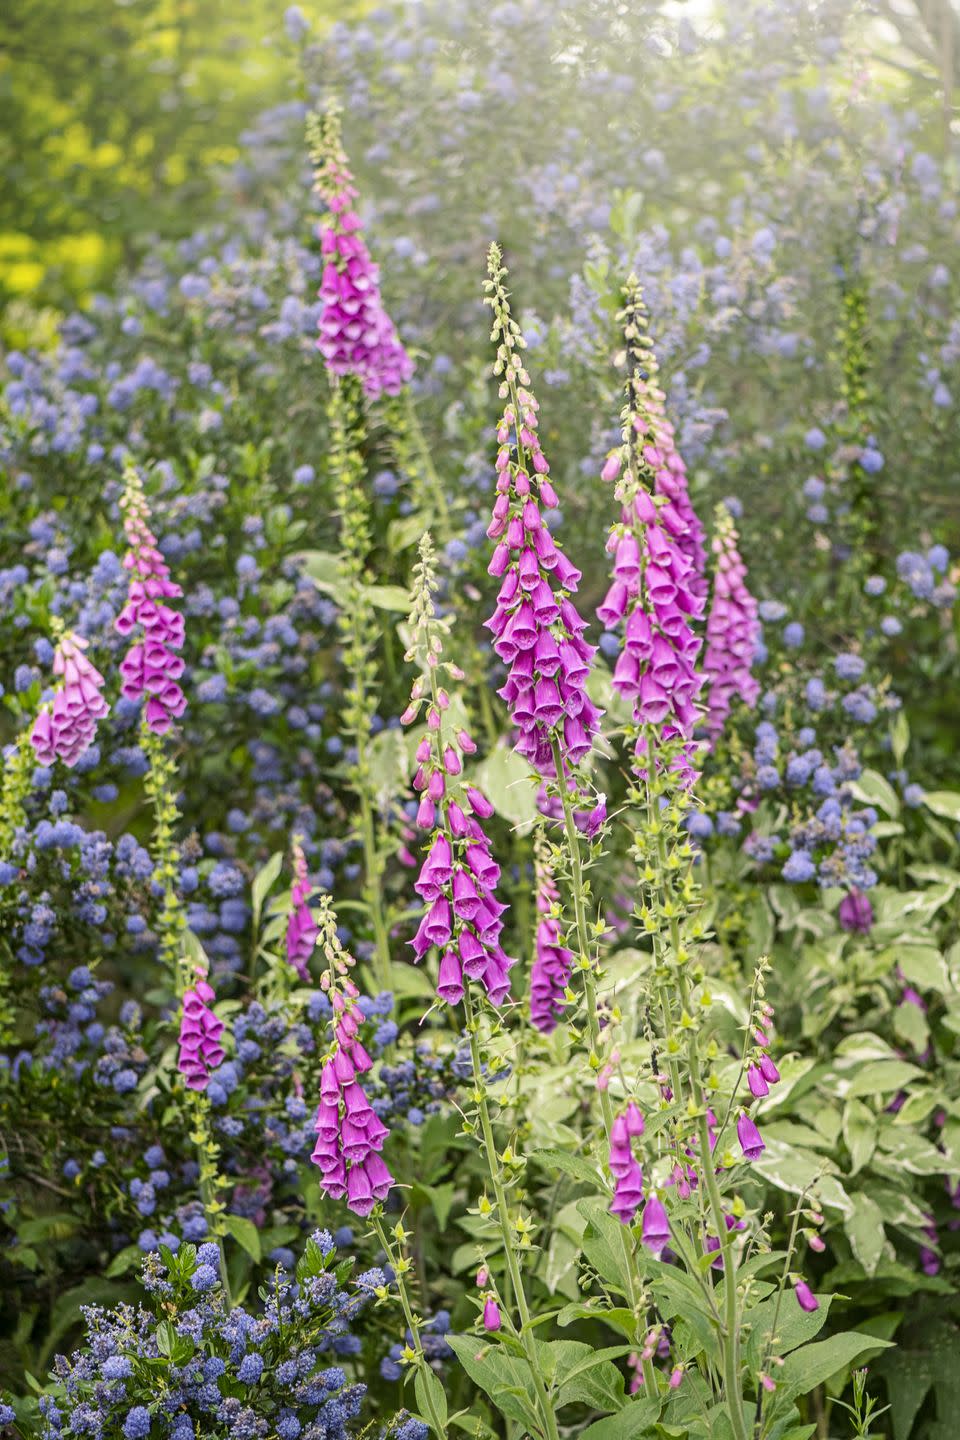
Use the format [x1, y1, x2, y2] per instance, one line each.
[114, 469, 187, 734]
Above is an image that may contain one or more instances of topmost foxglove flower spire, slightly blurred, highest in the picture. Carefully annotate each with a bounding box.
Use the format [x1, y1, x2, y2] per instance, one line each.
[308, 108, 413, 399]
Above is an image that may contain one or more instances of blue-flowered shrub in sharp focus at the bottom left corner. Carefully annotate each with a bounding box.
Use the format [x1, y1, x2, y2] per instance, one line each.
[40, 1231, 394, 1440]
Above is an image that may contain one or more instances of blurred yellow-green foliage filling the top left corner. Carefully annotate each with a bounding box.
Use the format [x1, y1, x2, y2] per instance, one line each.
[0, 0, 356, 307]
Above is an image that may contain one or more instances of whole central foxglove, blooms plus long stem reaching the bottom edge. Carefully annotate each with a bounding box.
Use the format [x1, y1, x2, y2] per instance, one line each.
[402, 536, 558, 1440]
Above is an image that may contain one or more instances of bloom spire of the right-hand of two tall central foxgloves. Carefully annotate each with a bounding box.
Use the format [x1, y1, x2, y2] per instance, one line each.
[597, 276, 704, 785]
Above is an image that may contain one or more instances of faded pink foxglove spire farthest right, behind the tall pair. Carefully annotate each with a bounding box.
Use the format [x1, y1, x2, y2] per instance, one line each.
[704, 505, 760, 746]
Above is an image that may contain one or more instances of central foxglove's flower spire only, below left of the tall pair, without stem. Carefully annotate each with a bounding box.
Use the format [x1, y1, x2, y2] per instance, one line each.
[400, 534, 515, 1005]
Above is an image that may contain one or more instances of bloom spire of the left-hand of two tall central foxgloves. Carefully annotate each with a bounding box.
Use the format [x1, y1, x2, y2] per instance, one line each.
[485, 245, 600, 778]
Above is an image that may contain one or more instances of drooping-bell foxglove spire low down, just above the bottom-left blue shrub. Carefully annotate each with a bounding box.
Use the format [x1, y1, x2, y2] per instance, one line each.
[311, 896, 393, 1215]
